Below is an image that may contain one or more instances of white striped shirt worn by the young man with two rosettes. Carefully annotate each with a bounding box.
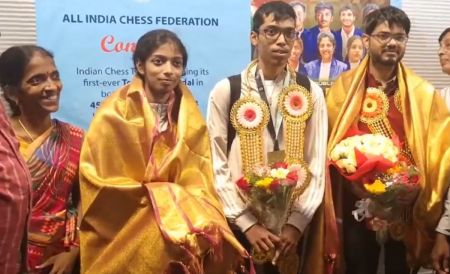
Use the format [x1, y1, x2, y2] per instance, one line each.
[207, 65, 328, 231]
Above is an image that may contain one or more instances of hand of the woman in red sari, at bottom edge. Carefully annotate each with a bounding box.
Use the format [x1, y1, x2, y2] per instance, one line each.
[36, 247, 80, 274]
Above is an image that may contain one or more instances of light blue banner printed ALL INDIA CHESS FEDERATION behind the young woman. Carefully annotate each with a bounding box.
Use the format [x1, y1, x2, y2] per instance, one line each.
[36, 0, 251, 129]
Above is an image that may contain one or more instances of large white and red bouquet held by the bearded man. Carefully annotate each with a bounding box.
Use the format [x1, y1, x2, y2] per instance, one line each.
[331, 134, 419, 225]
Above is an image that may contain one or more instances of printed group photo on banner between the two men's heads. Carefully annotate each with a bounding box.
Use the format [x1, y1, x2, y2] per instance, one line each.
[250, 0, 390, 93]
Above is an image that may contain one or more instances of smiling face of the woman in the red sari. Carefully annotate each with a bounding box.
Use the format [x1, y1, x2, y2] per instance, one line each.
[15, 51, 62, 116]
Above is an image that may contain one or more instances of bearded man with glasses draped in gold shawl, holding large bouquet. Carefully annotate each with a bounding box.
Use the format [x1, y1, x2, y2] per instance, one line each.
[326, 6, 450, 274]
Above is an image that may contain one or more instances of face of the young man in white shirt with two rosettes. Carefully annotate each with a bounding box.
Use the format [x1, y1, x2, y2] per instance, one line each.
[250, 14, 296, 67]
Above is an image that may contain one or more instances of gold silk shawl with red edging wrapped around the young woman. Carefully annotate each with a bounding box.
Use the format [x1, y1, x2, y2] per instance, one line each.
[80, 77, 247, 274]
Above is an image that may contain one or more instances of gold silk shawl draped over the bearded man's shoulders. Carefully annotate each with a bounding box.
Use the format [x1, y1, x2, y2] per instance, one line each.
[326, 57, 450, 266]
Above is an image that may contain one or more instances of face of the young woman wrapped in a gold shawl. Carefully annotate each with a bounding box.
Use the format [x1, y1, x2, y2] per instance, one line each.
[136, 41, 183, 97]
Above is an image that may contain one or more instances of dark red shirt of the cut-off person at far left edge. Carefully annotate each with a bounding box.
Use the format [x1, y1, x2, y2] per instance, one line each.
[0, 103, 31, 273]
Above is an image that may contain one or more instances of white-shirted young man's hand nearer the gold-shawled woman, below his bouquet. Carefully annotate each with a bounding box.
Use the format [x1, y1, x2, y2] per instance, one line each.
[245, 224, 280, 253]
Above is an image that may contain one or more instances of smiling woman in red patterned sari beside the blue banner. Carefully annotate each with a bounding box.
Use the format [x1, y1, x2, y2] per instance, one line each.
[0, 45, 83, 274]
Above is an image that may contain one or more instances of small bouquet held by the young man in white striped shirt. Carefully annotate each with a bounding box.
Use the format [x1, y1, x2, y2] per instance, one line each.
[236, 162, 309, 263]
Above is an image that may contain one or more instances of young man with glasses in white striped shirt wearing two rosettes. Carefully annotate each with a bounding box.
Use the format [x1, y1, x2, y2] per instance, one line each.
[207, 1, 327, 273]
